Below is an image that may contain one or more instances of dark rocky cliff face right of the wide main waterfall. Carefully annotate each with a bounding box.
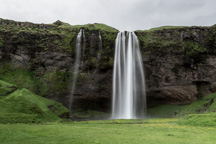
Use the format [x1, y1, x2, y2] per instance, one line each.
[137, 26, 216, 105]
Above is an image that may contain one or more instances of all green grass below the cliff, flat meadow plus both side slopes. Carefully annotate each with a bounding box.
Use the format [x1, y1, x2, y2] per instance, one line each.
[0, 80, 216, 144]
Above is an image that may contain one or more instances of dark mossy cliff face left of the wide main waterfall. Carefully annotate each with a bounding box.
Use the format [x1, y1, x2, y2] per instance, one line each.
[0, 19, 118, 114]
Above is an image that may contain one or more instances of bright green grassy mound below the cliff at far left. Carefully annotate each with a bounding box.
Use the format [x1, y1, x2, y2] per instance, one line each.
[0, 81, 68, 123]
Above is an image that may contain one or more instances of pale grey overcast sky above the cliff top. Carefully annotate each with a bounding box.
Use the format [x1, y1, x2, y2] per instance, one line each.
[0, 0, 216, 31]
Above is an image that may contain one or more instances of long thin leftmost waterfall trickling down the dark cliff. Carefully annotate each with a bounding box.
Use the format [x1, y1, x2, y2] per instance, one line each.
[69, 29, 85, 116]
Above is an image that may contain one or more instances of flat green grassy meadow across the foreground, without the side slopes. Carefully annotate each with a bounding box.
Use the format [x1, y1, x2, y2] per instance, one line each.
[0, 119, 216, 144]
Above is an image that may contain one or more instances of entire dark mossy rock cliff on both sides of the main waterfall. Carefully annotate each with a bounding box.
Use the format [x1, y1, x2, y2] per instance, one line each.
[0, 19, 216, 114]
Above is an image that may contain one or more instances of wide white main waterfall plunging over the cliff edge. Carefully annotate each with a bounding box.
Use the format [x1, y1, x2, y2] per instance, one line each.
[112, 32, 146, 119]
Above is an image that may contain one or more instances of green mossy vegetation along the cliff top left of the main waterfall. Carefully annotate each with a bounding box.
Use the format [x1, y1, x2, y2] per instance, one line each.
[0, 19, 118, 53]
